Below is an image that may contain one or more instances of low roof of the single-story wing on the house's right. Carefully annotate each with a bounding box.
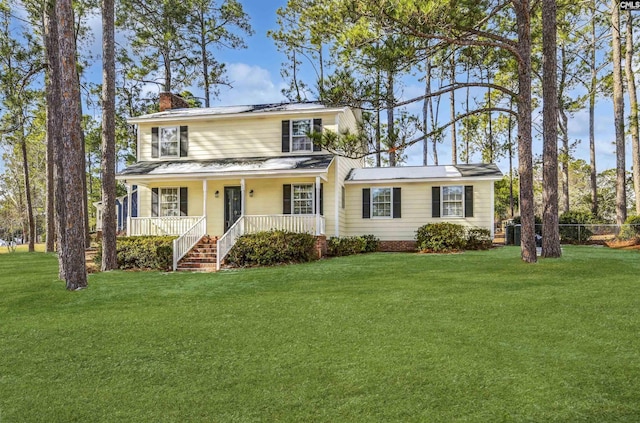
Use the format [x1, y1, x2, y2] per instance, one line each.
[346, 163, 502, 183]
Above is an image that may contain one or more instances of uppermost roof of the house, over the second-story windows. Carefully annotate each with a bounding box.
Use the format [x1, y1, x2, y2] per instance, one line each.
[128, 102, 344, 123]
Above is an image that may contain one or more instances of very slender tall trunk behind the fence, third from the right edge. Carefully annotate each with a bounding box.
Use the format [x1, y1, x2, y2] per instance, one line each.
[589, 0, 598, 217]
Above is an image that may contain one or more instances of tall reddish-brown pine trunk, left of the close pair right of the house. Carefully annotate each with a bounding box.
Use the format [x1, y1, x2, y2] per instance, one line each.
[513, 0, 538, 263]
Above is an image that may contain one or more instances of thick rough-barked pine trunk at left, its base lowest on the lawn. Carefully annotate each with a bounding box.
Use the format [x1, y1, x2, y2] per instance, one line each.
[55, 0, 87, 290]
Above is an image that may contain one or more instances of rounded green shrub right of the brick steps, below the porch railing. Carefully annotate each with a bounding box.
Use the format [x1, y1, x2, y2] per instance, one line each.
[227, 231, 316, 266]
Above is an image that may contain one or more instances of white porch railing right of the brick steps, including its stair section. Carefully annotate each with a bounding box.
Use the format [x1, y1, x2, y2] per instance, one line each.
[216, 214, 325, 270]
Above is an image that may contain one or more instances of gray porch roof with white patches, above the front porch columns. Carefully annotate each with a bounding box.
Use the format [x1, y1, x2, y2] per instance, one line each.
[118, 155, 333, 179]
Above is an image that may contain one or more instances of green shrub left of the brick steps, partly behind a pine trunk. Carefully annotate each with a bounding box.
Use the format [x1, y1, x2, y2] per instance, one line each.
[95, 236, 175, 271]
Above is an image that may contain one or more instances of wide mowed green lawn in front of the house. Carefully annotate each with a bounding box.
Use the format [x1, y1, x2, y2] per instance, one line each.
[0, 247, 640, 423]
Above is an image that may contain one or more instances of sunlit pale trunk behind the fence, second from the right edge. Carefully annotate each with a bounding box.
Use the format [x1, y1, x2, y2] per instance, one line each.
[611, 0, 627, 225]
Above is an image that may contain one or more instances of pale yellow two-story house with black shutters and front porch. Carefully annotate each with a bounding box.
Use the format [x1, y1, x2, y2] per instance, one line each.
[101, 94, 502, 268]
